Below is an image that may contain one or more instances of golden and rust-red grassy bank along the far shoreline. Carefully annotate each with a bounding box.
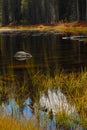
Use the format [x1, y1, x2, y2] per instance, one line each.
[0, 21, 87, 33]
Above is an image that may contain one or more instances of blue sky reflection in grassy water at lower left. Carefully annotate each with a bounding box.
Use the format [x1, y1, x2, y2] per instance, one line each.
[0, 98, 32, 120]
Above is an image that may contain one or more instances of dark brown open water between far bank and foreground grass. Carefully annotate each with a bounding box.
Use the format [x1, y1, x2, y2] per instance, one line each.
[0, 33, 87, 71]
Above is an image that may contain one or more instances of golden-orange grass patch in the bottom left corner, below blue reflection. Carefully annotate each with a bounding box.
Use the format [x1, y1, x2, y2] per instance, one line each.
[0, 116, 38, 130]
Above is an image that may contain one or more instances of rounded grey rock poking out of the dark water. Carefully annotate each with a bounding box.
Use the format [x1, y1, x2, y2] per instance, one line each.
[14, 51, 32, 61]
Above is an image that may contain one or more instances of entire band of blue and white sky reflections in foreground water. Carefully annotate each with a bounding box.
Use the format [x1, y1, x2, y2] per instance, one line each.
[0, 88, 83, 130]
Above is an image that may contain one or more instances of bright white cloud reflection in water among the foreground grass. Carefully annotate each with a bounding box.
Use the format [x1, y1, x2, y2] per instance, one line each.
[40, 89, 76, 115]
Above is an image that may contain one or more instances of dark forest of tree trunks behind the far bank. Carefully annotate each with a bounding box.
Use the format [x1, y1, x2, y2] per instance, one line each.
[0, 0, 87, 25]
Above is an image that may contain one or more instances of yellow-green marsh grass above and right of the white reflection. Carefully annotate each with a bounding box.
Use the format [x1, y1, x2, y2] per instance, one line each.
[30, 71, 87, 128]
